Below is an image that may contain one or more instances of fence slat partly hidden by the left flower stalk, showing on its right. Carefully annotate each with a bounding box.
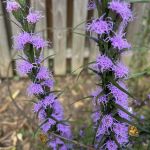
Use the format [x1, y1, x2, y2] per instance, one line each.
[31, 0, 49, 67]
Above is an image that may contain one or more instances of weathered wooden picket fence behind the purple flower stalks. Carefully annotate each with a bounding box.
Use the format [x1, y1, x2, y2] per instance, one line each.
[0, 0, 148, 77]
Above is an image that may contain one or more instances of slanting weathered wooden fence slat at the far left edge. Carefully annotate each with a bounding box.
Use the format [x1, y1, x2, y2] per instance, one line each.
[0, 1, 12, 77]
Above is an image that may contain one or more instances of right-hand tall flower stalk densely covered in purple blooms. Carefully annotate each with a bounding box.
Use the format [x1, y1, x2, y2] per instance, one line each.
[86, 0, 134, 150]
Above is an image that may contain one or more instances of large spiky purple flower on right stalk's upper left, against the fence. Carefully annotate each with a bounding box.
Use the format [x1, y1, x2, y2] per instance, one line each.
[86, 16, 113, 35]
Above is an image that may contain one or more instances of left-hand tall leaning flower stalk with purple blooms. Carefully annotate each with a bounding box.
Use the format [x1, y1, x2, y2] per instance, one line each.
[6, 0, 71, 150]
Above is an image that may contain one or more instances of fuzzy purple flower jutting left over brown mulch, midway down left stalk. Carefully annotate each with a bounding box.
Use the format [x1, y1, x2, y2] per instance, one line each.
[27, 83, 44, 96]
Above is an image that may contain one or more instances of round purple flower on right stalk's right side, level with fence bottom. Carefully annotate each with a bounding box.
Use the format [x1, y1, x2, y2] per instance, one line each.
[112, 62, 129, 78]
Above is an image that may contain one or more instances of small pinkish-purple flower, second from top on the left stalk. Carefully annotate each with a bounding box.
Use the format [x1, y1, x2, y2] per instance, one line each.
[27, 11, 42, 24]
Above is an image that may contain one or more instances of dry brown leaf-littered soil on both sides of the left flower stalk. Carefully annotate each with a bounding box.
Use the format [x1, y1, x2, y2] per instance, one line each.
[0, 74, 94, 150]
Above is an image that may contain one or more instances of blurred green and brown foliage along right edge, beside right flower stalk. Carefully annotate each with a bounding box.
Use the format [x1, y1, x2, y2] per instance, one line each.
[128, 4, 150, 150]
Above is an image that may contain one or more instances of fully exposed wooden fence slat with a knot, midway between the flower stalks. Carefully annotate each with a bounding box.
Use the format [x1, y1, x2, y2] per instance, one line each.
[52, 0, 67, 75]
